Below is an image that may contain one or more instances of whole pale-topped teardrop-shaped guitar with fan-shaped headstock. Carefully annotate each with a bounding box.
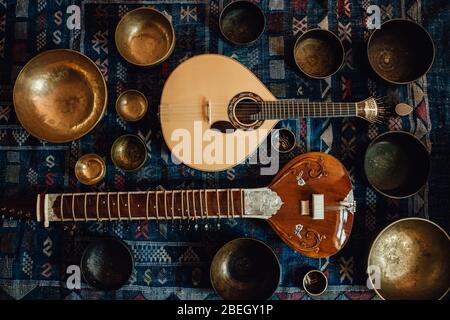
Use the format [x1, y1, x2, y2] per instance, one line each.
[159, 54, 385, 171]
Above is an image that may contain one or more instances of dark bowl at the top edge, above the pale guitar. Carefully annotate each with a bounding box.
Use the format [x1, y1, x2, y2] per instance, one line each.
[219, 0, 266, 45]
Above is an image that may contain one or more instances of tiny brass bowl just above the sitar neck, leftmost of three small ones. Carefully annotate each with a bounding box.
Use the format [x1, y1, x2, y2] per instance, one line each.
[75, 153, 106, 186]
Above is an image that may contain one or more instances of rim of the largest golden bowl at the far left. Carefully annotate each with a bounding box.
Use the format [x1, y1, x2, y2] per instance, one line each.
[12, 48, 108, 143]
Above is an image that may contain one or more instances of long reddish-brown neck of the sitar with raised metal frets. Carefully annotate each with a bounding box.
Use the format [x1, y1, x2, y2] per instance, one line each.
[37, 188, 282, 225]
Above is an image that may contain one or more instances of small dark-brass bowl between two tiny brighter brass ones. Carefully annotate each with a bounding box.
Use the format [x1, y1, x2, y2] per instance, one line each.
[111, 134, 147, 171]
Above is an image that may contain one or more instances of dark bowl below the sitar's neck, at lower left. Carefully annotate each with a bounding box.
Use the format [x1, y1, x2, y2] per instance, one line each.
[81, 238, 134, 291]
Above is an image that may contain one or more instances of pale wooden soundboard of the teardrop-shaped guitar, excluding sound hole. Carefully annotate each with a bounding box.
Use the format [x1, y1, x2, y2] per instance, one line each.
[159, 54, 278, 171]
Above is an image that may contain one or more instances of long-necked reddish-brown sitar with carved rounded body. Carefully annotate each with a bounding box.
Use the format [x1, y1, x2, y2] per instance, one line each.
[0, 152, 356, 258]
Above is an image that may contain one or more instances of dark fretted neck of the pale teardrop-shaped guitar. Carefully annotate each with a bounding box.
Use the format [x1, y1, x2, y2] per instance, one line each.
[251, 100, 357, 120]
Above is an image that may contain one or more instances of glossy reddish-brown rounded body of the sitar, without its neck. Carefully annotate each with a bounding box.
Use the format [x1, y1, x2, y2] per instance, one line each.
[268, 152, 355, 258]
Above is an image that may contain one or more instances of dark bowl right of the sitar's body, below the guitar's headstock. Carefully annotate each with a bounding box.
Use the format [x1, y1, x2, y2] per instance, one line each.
[364, 131, 430, 199]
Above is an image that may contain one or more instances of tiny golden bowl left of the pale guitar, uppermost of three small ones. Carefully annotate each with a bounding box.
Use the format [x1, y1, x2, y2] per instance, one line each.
[116, 90, 148, 121]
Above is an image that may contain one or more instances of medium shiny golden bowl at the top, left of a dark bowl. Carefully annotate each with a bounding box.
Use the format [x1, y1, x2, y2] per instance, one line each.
[115, 7, 175, 67]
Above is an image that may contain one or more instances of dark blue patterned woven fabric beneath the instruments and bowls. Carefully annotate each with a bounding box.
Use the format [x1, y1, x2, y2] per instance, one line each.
[0, 0, 450, 299]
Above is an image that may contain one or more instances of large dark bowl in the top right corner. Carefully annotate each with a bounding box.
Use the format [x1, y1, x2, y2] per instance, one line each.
[367, 19, 434, 84]
